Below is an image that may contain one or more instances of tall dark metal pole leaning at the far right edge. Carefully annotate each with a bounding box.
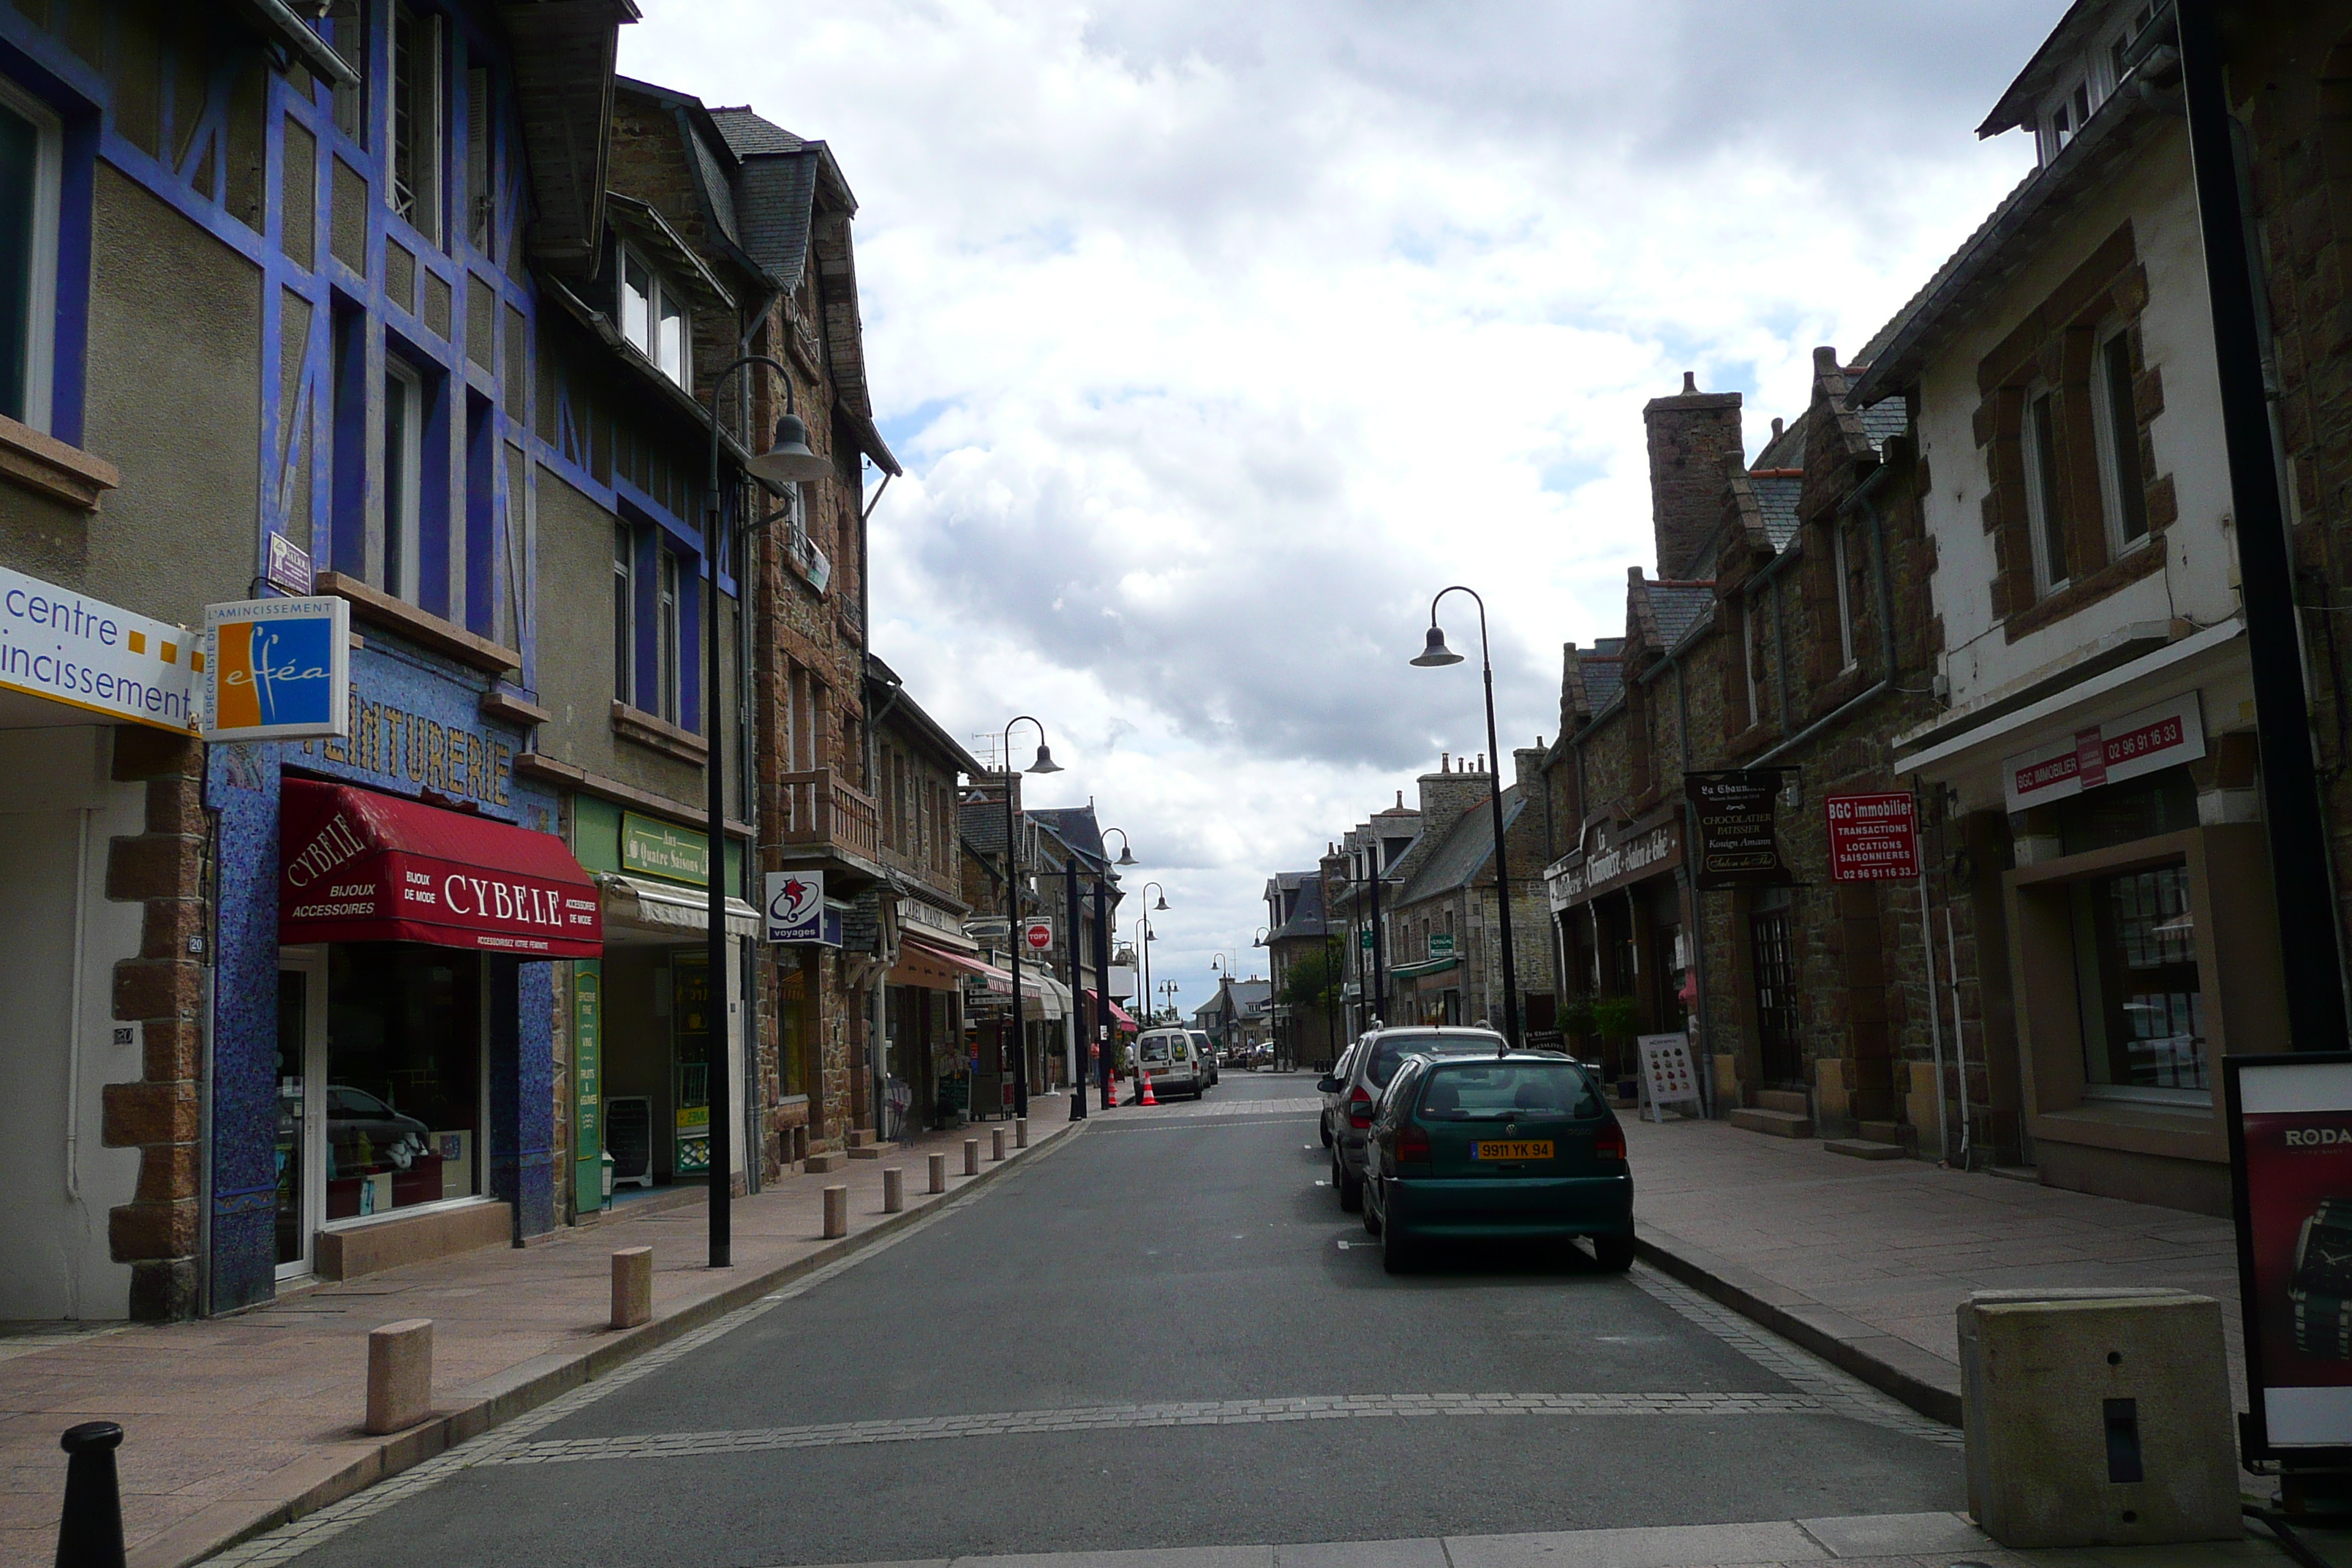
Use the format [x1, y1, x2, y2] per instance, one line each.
[2178, 0, 2348, 1051]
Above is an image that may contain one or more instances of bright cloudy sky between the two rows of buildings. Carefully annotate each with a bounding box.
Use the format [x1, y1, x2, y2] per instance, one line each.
[621, 0, 2065, 1025]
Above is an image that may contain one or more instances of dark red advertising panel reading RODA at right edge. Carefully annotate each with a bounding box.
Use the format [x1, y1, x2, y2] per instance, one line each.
[2220, 1051, 2352, 1460]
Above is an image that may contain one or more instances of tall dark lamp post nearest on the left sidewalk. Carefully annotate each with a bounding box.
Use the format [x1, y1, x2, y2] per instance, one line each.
[701, 355, 832, 1270]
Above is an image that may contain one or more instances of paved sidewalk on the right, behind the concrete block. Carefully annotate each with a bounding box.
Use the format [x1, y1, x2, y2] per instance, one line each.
[1623, 1115, 2246, 1425]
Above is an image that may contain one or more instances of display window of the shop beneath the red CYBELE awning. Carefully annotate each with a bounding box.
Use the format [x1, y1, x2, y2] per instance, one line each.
[327, 943, 484, 1222]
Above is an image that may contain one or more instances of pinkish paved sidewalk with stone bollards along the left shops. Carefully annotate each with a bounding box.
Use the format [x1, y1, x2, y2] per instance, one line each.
[0, 1096, 1077, 1568]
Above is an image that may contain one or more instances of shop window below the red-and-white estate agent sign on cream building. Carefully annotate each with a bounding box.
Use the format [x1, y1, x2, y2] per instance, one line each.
[2068, 865, 2211, 1105]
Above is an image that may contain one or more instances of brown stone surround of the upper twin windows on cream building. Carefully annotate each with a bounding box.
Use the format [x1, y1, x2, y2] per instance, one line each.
[1973, 219, 2178, 642]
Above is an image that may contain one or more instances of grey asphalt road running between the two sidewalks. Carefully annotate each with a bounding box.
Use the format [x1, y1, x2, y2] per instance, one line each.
[275, 1072, 1964, 1568]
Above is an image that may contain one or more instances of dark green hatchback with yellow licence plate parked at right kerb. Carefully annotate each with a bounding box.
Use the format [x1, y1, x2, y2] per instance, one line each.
[1364, 1051, 1632, 1274]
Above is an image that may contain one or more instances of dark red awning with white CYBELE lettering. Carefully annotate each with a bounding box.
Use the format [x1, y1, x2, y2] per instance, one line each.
[277, 778, 605, 959]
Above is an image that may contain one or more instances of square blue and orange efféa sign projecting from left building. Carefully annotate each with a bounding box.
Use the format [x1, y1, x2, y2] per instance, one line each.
[205, 597, 350, 741]
